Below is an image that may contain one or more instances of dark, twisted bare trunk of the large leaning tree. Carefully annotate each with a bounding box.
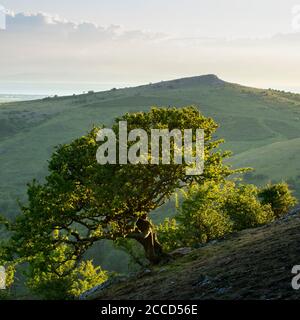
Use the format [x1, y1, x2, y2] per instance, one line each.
[128, 218, 167, 264]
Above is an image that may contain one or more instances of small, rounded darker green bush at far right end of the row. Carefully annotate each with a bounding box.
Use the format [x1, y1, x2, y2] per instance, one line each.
[259, 182, 297, 218]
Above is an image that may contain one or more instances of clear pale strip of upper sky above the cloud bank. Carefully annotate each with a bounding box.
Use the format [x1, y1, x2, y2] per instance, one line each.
[0, 0, 300, 37]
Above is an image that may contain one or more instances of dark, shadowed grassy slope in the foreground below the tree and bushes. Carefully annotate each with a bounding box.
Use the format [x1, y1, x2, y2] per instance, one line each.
[94, 212, 300, 300]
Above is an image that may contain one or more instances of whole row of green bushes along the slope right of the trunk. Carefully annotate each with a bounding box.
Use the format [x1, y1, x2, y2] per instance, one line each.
[157, 181, 295, 251]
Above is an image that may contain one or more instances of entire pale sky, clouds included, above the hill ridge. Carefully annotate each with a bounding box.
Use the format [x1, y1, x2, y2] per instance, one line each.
[0, 0, 300, 94]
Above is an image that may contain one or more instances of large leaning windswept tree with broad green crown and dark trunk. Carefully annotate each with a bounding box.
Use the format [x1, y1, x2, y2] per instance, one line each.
[3, 106, 233, 272]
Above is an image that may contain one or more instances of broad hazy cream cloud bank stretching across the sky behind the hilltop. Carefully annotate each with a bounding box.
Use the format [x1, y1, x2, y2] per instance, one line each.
[0, 13, 300, 91]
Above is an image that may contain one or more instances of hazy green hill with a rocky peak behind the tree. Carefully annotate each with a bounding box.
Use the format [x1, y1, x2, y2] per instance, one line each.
[0, 75, 300, 271]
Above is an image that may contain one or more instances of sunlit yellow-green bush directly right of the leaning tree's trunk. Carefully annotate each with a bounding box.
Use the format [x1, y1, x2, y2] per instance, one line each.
[157, 183, 232, 251]
